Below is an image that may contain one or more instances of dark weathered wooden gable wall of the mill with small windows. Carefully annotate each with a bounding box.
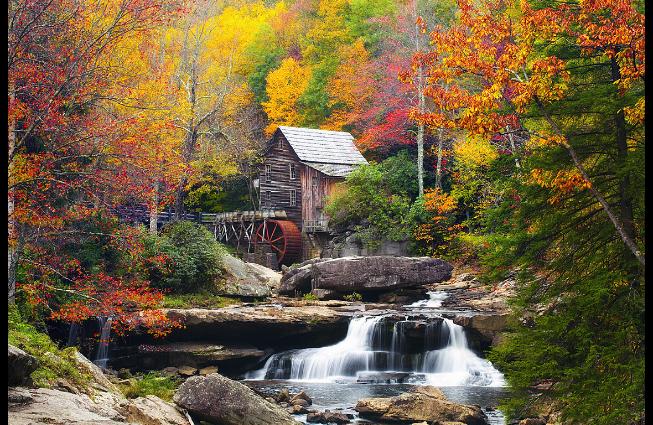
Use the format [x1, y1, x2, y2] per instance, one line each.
[259, 132, 303, 229]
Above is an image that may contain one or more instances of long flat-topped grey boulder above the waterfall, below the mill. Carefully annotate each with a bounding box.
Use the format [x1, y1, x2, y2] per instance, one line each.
[279, 256, 453, 295]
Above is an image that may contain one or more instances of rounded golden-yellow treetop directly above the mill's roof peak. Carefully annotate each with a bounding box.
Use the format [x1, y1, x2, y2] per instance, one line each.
[262, 58, 311, 135]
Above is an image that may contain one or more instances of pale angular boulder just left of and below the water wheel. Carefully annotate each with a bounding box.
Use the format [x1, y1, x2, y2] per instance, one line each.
[216, 254, 281, 298]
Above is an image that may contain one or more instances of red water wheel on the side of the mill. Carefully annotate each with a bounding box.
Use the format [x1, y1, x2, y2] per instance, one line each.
[254, 220, 302, 265]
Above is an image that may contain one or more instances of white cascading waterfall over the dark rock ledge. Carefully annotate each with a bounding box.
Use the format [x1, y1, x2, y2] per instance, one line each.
[245, 316, 505, 386]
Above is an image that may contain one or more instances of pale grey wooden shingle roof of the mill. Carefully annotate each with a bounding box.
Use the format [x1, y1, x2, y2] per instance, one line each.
[279, 126, 367, 165]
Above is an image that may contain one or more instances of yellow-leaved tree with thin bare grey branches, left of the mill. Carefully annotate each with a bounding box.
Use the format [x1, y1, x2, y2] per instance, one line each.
[167, 2, 281, 217]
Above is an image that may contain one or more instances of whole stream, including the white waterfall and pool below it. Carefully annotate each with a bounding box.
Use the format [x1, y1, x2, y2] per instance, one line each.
[244, 291, 506, 425]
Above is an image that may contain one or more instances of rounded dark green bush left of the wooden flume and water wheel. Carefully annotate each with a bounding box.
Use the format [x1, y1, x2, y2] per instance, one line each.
[143, 221, 225, 293]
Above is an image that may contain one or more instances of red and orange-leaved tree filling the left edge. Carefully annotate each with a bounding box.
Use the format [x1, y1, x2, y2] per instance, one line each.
[8, 0, 186, 335]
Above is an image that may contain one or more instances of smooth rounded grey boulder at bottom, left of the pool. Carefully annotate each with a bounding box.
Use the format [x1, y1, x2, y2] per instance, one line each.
[174, 373, 299, 425]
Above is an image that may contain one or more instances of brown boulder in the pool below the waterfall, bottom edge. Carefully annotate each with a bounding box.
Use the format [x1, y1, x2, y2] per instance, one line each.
[356, 386, 488, 425]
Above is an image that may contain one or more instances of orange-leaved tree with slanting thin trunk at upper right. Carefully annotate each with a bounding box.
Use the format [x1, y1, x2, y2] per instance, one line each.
[422, 1, 644, 265]
